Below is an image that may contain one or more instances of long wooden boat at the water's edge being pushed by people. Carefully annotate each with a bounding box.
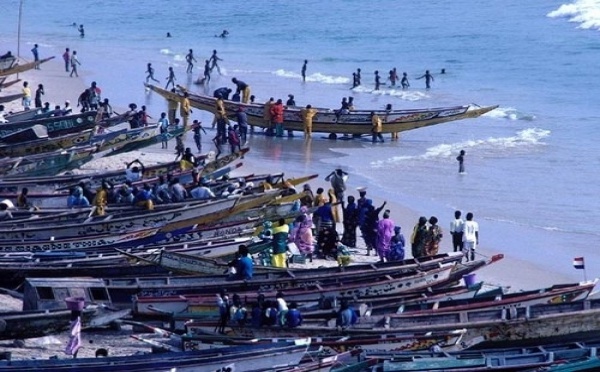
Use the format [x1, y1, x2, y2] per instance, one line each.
[146, 84, 498, 135]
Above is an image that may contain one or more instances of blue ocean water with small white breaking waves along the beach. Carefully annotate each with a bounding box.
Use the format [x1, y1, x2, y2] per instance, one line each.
[0, 0, 600, 280]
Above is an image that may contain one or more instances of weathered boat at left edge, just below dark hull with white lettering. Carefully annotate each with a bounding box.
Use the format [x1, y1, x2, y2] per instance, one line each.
[0, 129, 93, 157]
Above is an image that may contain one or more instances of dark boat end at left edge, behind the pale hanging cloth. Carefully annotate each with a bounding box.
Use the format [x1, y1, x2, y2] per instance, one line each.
[0, 306, 130, 340]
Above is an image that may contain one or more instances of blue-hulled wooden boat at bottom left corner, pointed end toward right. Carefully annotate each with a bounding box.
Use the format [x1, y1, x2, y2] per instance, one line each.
[0, 339, 310, 372]
